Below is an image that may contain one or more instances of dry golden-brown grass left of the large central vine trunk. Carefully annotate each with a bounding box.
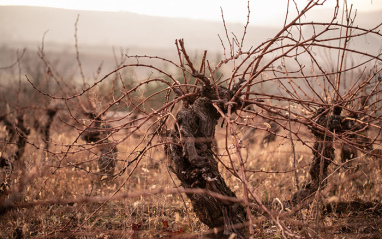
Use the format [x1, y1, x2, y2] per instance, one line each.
[0, 127, 206, 238]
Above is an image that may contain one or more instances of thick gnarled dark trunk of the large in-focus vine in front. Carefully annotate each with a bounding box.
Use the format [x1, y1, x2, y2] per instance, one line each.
[169, 87, 247, 238]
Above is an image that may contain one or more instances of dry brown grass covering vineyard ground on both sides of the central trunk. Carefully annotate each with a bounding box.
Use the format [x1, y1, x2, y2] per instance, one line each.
[0, 124, 382, 238]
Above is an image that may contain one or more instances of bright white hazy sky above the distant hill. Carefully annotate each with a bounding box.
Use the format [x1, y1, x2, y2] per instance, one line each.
[0, 0, 382, 24]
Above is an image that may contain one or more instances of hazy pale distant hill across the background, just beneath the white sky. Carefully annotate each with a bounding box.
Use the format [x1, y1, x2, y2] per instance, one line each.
[0, 6, 382, 78]
